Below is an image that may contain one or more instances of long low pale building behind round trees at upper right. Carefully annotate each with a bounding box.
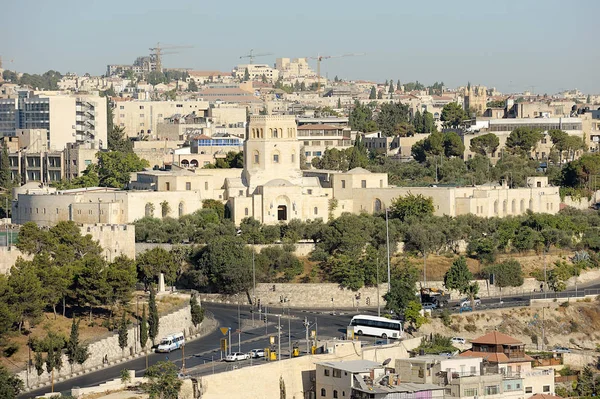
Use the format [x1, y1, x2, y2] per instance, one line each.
[462, 117, 585, 164]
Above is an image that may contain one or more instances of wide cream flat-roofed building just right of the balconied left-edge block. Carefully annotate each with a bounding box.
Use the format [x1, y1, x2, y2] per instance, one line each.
[113, 99, 209, 137]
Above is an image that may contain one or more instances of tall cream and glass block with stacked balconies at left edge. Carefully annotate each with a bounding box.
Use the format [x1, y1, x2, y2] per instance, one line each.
[0, 91, 107, 151]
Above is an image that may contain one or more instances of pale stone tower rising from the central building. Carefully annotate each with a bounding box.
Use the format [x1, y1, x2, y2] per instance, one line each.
[243, 115, 302, 193]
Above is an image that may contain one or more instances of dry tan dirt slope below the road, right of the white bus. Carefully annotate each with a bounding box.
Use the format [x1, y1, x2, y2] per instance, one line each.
[420, 300, 600, 350]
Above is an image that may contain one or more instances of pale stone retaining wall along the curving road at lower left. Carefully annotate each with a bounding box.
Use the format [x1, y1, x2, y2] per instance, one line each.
[17, 294, 205, 390]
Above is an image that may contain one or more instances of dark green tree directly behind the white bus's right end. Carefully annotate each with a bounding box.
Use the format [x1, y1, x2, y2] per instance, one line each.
[383, 262, 419, 314]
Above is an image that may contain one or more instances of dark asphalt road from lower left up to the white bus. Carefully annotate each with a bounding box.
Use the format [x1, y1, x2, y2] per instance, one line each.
[21, 303, 360, 398]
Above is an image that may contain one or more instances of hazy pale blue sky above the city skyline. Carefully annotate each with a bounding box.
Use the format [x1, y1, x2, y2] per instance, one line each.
[0, 0, 600, 94]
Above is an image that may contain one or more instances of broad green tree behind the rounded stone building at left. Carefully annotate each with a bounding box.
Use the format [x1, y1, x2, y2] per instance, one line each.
[95, 151, 149, 188]
